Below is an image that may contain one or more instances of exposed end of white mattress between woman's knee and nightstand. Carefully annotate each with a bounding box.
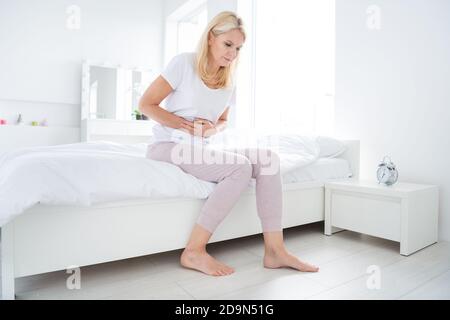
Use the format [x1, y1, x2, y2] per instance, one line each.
[282, 158, 352, 184]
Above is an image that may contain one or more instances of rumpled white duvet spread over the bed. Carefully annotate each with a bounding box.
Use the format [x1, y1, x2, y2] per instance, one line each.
[0, 135, 320, 226]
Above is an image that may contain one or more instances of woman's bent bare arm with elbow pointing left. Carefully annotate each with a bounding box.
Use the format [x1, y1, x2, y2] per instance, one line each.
[139, 76, 194, 130]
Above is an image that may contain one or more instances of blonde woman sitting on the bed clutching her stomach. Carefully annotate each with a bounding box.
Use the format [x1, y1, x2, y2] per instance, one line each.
[139, 12, 318, 276]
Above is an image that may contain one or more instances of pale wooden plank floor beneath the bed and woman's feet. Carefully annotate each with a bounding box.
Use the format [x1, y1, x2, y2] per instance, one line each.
[4, 223, 450, 299]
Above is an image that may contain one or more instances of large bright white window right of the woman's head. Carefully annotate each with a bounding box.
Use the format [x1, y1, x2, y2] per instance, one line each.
[236, 0, 335, 135]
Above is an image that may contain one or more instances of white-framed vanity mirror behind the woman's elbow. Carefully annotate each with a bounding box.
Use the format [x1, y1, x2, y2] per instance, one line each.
[81, 62, 154, 120]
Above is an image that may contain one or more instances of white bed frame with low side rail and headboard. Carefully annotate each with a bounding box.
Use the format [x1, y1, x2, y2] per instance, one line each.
[1, 140, 359, 299]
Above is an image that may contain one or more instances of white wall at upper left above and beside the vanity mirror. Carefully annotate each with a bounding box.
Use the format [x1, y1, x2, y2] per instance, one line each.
[0, 0, 163, 126]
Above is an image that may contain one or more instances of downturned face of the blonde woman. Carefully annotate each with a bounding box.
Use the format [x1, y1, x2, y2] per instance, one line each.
[208, 29, 244, 67]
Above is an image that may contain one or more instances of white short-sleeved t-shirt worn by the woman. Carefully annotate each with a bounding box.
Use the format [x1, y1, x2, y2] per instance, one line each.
[153, 52, 236, 145]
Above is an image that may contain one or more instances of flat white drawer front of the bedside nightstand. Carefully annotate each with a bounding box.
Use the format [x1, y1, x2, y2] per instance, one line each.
[331, 190, 401, 241]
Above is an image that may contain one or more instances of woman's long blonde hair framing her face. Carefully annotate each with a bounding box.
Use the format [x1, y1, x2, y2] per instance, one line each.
[196, 11, 246, 88]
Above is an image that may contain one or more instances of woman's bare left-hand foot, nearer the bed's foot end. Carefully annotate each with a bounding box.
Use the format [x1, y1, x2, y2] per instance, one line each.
[180, 249, 234, 276]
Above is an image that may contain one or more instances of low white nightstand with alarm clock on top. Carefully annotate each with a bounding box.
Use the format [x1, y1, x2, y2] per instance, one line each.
[325, 180, 439, 256]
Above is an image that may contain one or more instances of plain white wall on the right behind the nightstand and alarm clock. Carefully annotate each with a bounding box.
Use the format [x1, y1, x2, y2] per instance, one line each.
[335, 0, 450, 240]
